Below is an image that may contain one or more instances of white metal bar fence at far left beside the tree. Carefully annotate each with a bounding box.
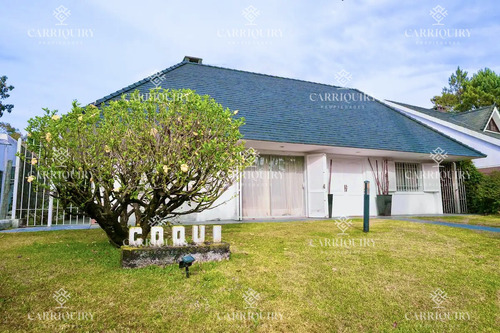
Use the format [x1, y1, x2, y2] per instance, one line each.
[12, 139, 91, 227]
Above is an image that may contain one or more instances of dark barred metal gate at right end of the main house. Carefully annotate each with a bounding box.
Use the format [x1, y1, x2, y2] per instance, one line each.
[440, 162, 467, 214]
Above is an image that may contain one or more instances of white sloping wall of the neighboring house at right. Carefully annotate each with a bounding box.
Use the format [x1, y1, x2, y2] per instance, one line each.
[399, 109, 500, 168]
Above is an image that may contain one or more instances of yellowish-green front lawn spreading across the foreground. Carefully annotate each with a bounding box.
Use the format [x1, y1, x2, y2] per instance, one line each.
[0, 219, 500, 332]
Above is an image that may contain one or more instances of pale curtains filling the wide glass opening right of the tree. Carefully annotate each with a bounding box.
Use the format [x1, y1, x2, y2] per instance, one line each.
[242, 155, 305, 217]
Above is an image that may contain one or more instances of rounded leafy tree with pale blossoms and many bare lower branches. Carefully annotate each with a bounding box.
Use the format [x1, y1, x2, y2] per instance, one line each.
[27, 89, 254, 246]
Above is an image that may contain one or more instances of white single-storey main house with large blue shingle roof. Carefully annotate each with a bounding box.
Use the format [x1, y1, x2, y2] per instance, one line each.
[95, 57, 485, 221]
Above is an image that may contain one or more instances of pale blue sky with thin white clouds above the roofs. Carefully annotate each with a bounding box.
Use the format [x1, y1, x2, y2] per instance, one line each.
[0, 0, 500, 133]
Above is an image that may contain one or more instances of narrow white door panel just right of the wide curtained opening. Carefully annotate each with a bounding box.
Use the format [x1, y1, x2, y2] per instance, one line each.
[306, 154, 328, 217]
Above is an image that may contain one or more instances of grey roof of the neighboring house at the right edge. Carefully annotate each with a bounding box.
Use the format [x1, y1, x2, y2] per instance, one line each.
[389, 101, 500, 139]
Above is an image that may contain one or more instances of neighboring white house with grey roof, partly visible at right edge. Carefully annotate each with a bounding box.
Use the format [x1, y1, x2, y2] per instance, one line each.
[386, 101, 500, 174]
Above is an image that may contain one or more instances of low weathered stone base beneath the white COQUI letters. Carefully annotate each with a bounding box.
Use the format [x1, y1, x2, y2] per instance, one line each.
[120, 242, 231, 268]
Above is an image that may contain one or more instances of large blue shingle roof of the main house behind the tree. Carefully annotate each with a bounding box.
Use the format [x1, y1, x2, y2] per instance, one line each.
[96, 61, 485, 157]
